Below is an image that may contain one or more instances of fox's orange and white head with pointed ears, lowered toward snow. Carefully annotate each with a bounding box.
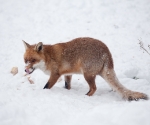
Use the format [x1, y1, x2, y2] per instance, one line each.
[23, 41, 44, 74]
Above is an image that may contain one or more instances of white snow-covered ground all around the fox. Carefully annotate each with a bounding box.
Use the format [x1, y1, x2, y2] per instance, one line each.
[0, 0, 150, 125]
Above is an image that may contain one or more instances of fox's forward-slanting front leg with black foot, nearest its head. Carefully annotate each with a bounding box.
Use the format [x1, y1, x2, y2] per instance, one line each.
[43, 73, 60, 89]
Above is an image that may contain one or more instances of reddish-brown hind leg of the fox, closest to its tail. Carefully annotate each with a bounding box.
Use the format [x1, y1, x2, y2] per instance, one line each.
[84, 73, 96, 96]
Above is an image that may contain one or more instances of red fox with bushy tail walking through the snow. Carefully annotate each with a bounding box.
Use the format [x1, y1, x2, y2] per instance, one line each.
[23, 37, 148, 101]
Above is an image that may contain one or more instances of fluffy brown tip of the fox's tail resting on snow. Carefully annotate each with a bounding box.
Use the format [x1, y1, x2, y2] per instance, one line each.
[123, 91, 148, 101]
